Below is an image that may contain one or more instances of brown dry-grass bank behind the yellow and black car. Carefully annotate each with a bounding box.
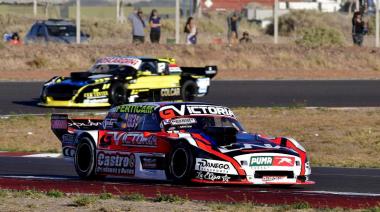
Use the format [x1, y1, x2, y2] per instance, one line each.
[0, 44, 380, 80]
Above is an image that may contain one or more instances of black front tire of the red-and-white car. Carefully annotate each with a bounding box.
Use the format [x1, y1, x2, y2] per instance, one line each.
[168, 142, 194, 184]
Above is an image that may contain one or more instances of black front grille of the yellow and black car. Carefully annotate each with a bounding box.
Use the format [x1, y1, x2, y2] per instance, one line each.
[46, 84, 80, 101]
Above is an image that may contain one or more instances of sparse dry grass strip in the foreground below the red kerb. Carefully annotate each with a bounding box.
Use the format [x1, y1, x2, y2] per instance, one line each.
[0, 190, 370, 212]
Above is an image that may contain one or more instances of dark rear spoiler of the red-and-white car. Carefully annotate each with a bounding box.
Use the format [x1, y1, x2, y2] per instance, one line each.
[50, 114, 103, 140]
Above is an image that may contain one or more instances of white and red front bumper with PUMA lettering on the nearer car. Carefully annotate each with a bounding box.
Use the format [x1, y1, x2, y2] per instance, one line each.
[192, 153, 315, 185]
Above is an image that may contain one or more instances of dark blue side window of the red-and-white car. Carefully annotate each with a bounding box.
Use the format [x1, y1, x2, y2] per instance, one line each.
[103, 112, 161, 132]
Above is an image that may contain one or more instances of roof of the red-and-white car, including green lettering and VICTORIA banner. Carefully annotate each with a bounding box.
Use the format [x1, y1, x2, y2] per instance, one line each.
[110, 102, 235, 119]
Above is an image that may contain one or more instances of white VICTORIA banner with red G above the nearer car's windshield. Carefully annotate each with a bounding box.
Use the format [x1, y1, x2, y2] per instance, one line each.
[160, 105, 235, 119]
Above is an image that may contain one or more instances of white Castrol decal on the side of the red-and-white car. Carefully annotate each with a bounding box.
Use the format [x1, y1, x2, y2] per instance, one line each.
[96, 151, 135, 175]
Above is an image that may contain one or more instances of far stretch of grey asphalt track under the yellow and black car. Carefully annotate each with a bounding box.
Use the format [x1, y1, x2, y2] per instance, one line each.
[0, 80, 380, 115]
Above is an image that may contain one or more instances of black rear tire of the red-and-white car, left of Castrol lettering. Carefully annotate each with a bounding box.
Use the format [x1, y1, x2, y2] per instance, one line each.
[74, 137, 96, 180]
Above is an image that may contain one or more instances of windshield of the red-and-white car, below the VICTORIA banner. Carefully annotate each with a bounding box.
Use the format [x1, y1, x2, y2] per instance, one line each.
[163, 116, 244, 132]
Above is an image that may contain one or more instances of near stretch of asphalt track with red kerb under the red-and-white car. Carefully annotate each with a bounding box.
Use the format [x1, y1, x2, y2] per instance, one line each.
[0, 157, 380, 208]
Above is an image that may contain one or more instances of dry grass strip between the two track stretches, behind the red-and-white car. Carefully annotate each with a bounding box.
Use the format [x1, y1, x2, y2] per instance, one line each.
[0, 107, 380, 168]
